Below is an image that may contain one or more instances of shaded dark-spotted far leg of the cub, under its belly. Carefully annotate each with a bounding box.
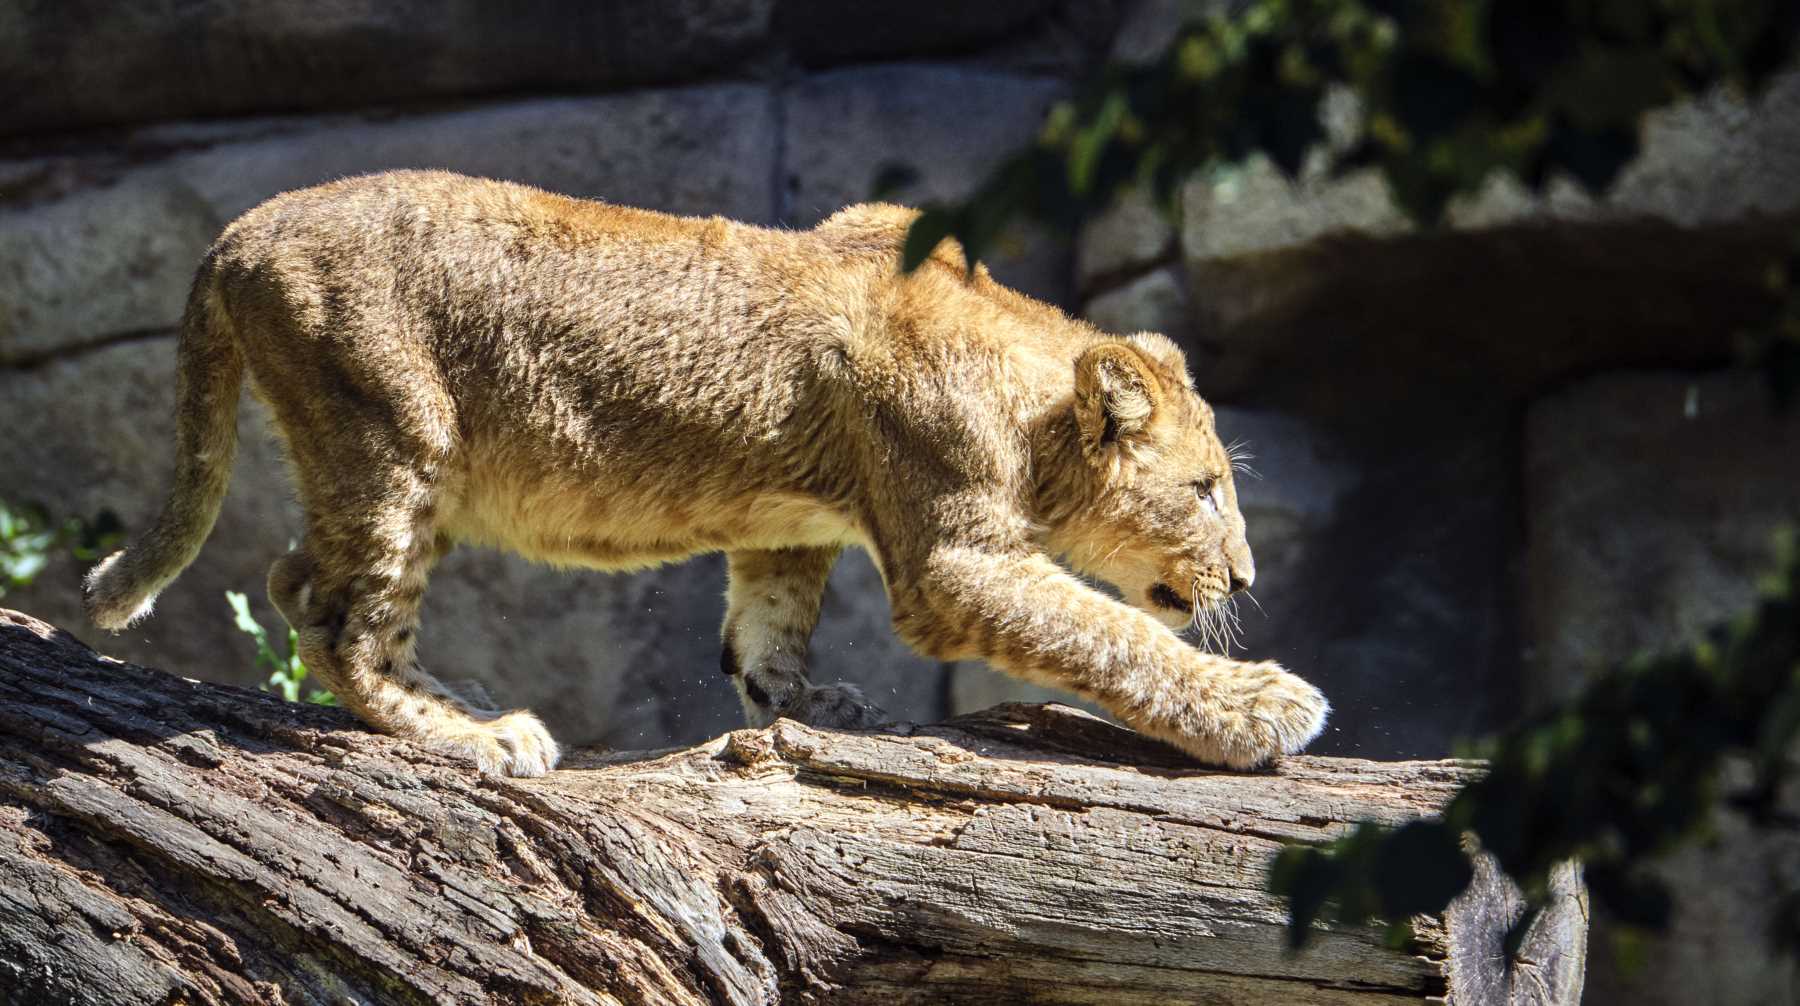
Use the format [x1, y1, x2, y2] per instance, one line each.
[720, 549, 884, 727]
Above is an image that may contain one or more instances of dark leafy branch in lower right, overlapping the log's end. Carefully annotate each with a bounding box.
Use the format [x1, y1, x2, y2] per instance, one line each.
[1269, 531, 1800, 954]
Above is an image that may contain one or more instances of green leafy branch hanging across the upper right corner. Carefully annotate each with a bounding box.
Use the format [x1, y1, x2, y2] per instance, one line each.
[902, 0, 1800, 272]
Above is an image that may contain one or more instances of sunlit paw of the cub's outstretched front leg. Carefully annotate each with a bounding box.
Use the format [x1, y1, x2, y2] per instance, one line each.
[1148, 662, 1330, 768]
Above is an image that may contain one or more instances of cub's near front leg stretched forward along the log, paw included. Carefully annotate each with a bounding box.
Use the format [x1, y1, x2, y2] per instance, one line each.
[895, 547, 1330, 768]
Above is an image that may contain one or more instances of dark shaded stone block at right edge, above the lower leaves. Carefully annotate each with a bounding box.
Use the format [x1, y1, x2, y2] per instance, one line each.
[1525, 373, 1800, 702]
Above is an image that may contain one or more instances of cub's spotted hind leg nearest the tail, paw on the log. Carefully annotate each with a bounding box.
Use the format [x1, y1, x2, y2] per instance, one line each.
[268, 470, 558, 776]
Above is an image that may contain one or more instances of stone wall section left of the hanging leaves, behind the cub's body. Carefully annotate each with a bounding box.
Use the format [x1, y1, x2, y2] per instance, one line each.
[0, 0, 1120, 747]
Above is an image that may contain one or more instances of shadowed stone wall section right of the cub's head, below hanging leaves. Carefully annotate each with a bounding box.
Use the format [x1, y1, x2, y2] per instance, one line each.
[1065, 5, 1800, 1006]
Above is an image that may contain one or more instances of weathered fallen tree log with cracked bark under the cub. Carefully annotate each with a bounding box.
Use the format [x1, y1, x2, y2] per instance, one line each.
[0, 610, 1586, 1006]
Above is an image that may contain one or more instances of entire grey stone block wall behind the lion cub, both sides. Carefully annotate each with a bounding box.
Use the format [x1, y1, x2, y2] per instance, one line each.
[0, 0, 1800, 1002]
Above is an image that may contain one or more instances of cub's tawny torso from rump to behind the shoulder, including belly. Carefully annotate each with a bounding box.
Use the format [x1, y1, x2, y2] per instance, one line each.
[209, 171, 856, 550]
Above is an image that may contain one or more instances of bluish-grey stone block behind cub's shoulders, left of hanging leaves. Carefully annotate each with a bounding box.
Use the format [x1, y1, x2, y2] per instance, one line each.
[783, 65, 1069, 304]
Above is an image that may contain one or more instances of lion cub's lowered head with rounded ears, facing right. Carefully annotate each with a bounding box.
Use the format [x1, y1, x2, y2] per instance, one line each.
[1051, 335, 1256, 644]
